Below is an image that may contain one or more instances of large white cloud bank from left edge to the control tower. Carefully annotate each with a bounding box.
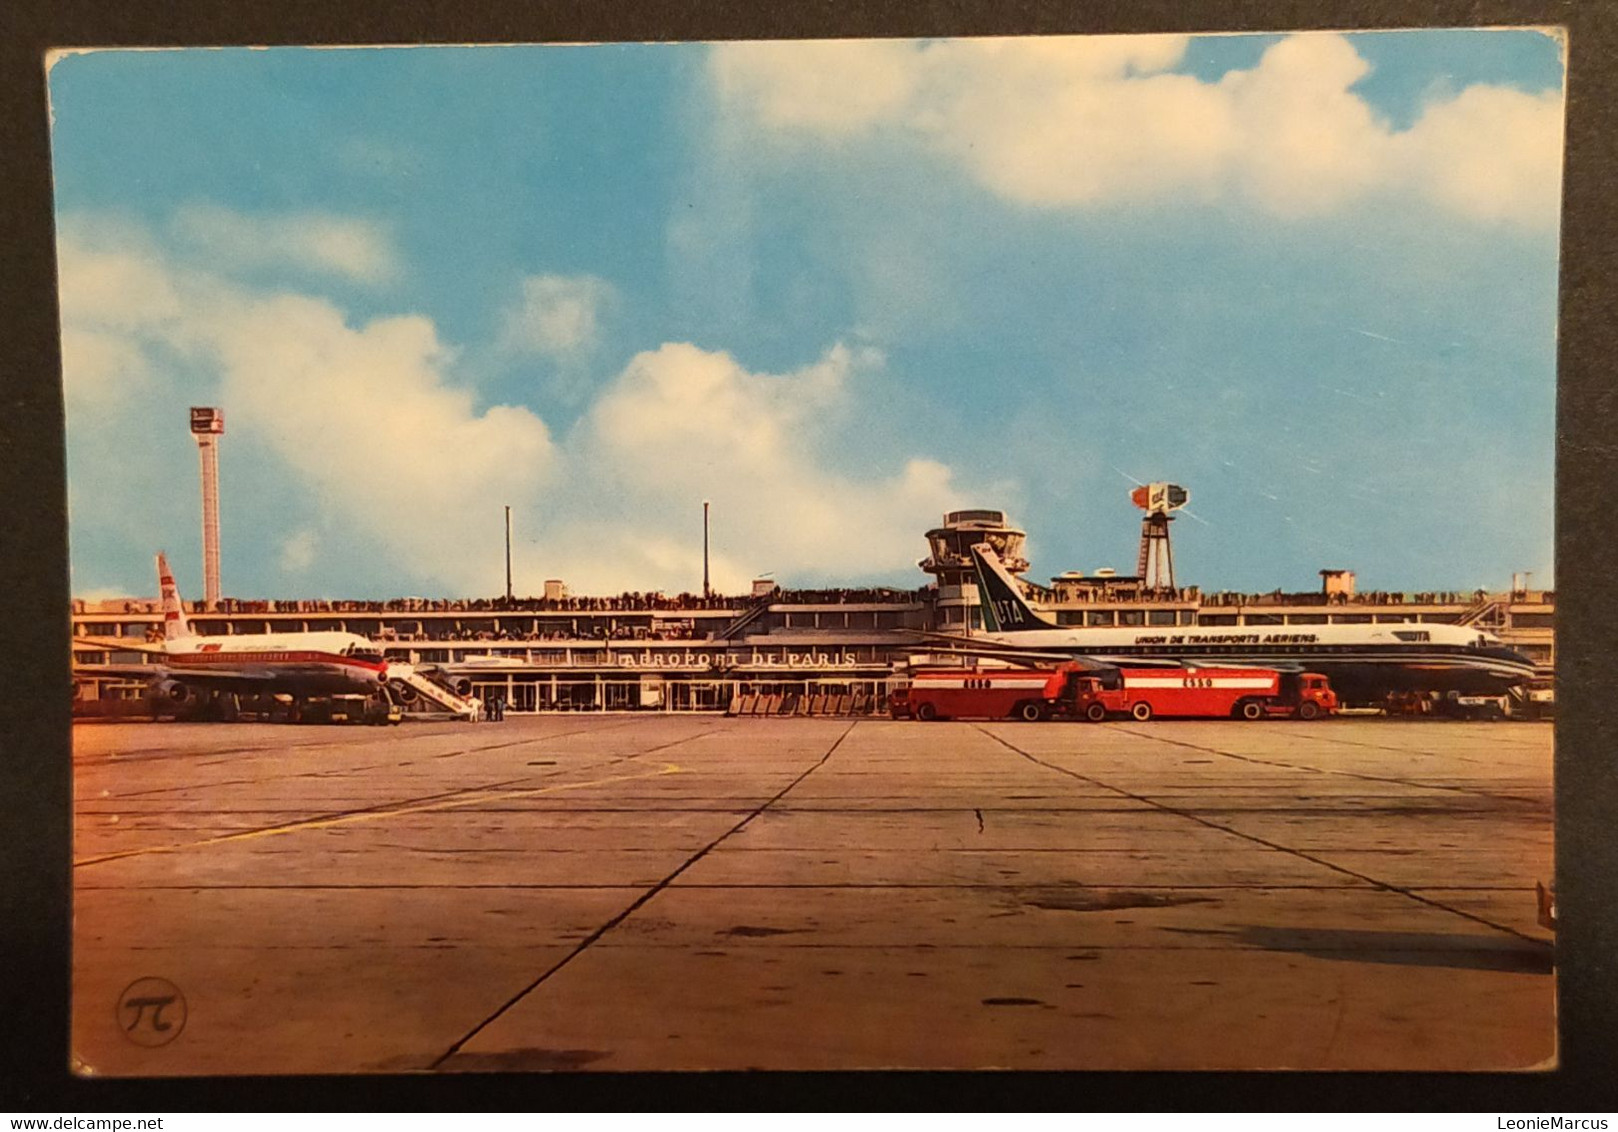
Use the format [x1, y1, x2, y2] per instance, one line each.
[58, 218, 966, 593]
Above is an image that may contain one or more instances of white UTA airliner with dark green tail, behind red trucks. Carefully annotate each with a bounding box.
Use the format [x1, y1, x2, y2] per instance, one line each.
[932, 543, 1535, 703]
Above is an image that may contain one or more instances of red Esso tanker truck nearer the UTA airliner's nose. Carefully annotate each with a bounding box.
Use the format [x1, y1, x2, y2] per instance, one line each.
[1069, 668, 1336, 723]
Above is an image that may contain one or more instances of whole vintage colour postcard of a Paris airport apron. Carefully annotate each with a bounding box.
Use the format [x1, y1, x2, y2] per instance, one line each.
[49, 27, 1566, 1077]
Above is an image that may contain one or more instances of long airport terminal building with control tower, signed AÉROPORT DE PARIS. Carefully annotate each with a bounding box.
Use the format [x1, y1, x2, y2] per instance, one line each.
[73, 509, 1555, 713]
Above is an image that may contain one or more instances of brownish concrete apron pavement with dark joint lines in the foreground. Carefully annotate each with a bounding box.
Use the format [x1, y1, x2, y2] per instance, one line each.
[73, 715, 1555, 1075]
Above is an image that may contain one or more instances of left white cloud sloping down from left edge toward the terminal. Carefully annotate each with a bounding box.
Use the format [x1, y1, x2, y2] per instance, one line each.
[58, 220, 553, 592]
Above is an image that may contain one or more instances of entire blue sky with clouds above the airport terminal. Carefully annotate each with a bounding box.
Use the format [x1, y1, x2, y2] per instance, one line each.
[50, 31, 1563, 597]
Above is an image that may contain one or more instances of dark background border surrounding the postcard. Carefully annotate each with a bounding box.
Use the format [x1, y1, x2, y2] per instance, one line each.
[0, 0, 1618, 1116]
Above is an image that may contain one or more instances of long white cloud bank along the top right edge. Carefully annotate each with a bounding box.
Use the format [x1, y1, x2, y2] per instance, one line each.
[712, 32, 1561, 225]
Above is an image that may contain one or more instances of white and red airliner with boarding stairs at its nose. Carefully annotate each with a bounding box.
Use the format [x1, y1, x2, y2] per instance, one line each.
[73, 551, 388, 713]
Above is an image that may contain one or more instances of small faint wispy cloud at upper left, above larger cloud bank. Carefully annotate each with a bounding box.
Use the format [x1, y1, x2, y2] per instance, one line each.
[173, 204, 400, 283]
